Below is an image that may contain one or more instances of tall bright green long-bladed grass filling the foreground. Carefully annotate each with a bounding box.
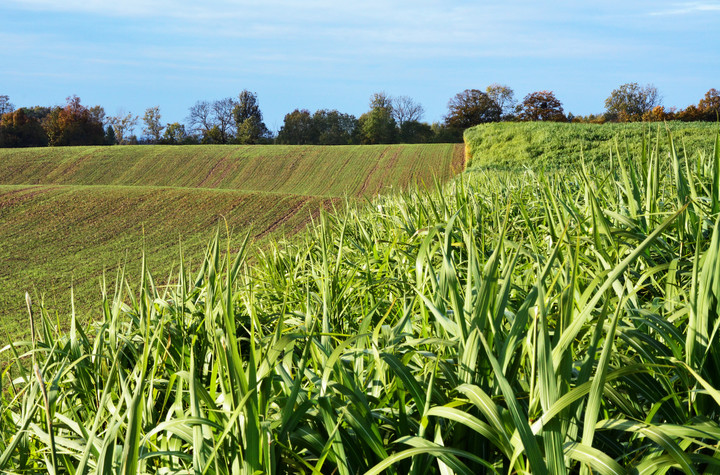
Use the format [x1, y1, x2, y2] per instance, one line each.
[0, 128, 720, 474]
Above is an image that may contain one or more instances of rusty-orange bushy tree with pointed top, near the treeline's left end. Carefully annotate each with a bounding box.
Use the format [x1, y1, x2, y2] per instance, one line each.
[42, 96, 105, 146]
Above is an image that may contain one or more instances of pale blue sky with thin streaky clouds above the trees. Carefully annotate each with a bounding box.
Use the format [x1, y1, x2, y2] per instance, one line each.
[0, 0, 720, 134]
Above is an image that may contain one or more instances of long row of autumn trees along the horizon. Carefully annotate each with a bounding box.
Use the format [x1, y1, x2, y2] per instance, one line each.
[0, 83, 720, 147]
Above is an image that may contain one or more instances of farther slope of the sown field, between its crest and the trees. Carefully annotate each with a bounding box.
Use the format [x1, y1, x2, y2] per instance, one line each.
[0, 144, 464, 197]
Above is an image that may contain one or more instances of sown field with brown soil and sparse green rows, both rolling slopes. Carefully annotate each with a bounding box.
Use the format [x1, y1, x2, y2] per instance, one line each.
[0, 145, 464, 338]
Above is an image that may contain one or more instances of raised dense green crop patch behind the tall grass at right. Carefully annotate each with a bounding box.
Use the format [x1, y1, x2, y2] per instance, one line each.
[465, 122, 718, 169]
